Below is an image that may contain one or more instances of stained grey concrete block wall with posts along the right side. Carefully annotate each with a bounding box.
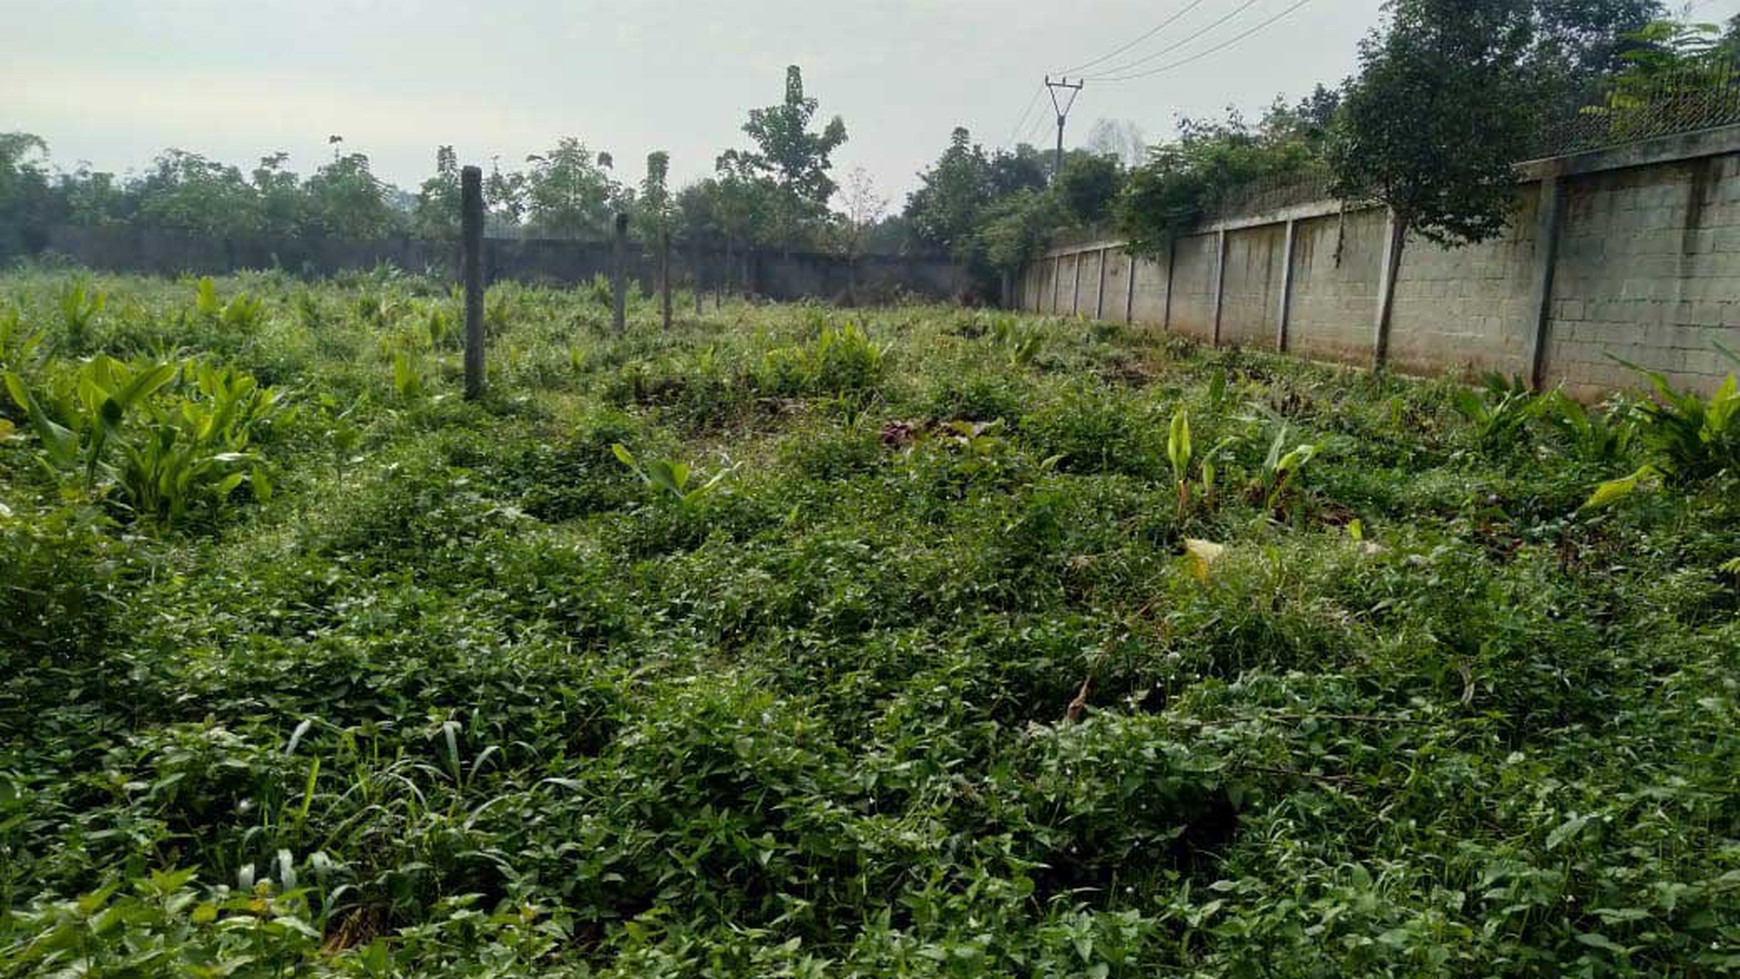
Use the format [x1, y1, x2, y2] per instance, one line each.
[1025, 127, 1740, 398]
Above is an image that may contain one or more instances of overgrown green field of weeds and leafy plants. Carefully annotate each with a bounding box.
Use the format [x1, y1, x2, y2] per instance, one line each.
[0, 271, 1740, 977]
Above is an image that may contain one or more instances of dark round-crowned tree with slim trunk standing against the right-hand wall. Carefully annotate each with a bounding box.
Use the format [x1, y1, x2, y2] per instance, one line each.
[1331, 0, 1538, 365]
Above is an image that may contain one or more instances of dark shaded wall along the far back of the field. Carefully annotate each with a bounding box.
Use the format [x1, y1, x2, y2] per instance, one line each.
[30, 226, 967, 299]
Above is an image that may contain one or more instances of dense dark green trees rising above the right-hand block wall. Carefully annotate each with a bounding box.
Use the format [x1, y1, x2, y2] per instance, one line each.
[903, 0, 1740, 293]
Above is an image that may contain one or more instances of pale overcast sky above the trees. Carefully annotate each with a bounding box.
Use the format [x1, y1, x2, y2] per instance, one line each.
[10, 0, 1740, 207]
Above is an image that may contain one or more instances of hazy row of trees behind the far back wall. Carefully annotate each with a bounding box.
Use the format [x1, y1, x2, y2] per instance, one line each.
[0, 66, 898, 266]
